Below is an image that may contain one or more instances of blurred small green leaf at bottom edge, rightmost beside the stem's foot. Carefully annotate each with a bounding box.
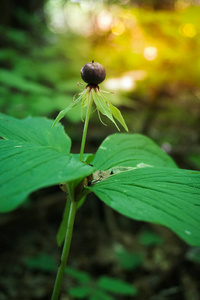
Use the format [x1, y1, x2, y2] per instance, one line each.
[97, 276, 137, 296]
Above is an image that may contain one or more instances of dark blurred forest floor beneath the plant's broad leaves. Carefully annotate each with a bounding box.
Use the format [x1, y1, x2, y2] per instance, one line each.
[0, 187, 200, 300]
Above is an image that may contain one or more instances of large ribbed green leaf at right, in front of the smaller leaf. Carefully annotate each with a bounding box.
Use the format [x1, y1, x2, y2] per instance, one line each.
[89, 168, 200, 246]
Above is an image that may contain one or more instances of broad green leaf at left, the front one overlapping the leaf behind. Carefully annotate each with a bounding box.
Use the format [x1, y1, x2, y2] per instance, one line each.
[0, 140, 92, 212]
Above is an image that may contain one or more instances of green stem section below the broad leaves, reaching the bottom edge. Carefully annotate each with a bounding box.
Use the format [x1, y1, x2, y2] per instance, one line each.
[51, 195, 77, 300]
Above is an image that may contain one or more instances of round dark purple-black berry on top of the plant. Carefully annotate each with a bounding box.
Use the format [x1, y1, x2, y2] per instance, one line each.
[81, 61, 106, 85]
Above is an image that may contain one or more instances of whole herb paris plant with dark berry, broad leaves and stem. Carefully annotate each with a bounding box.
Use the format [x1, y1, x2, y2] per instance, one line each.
[0, 62, 200, 300]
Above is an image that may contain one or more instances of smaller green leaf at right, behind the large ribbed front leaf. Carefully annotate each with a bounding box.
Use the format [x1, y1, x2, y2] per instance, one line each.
[92, 133, 176, 170]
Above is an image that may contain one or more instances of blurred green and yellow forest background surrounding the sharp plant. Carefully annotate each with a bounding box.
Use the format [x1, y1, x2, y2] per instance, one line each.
[0, 0, 200, 300]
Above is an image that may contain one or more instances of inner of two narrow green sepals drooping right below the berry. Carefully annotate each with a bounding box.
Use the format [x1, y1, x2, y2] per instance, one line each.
[92, 90, 120, 131]
